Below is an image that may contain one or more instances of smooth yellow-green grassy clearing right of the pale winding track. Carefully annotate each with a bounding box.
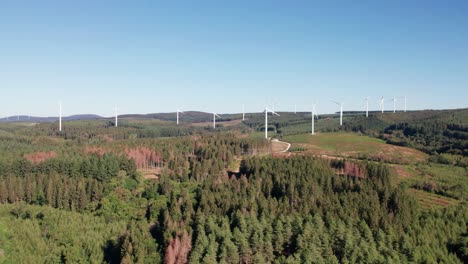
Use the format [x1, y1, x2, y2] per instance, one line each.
[284, 133, 426, 164]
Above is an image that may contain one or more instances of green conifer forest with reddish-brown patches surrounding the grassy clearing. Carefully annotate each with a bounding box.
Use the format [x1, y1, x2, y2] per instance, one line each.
[0, 111, 468, 263]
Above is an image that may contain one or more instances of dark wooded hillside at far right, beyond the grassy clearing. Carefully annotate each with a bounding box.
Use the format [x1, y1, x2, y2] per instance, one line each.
[343, 109, 468, 156]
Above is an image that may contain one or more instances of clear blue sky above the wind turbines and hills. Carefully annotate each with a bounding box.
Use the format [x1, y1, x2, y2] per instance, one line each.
[0, 0, 468, 116]
